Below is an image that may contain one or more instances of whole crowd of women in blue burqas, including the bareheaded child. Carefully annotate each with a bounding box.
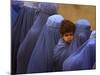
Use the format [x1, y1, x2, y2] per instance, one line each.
[11, 2, 96, 74]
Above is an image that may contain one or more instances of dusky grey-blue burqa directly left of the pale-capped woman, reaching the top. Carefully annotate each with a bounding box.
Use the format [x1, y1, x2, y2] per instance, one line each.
[17, 3, 57, 73]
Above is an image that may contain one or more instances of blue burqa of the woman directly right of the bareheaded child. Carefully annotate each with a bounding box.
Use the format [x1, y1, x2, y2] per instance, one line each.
[69, 19, 91, 54]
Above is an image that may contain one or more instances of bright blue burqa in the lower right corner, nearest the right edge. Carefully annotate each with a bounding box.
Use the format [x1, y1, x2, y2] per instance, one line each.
[63, 31, 96, 71]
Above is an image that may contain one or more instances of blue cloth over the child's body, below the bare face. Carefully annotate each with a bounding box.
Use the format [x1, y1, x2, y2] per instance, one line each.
[53, 38, 70, 71]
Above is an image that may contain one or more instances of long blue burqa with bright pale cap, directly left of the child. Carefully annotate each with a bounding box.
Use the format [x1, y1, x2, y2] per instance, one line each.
[27, 14, 64, 73]
